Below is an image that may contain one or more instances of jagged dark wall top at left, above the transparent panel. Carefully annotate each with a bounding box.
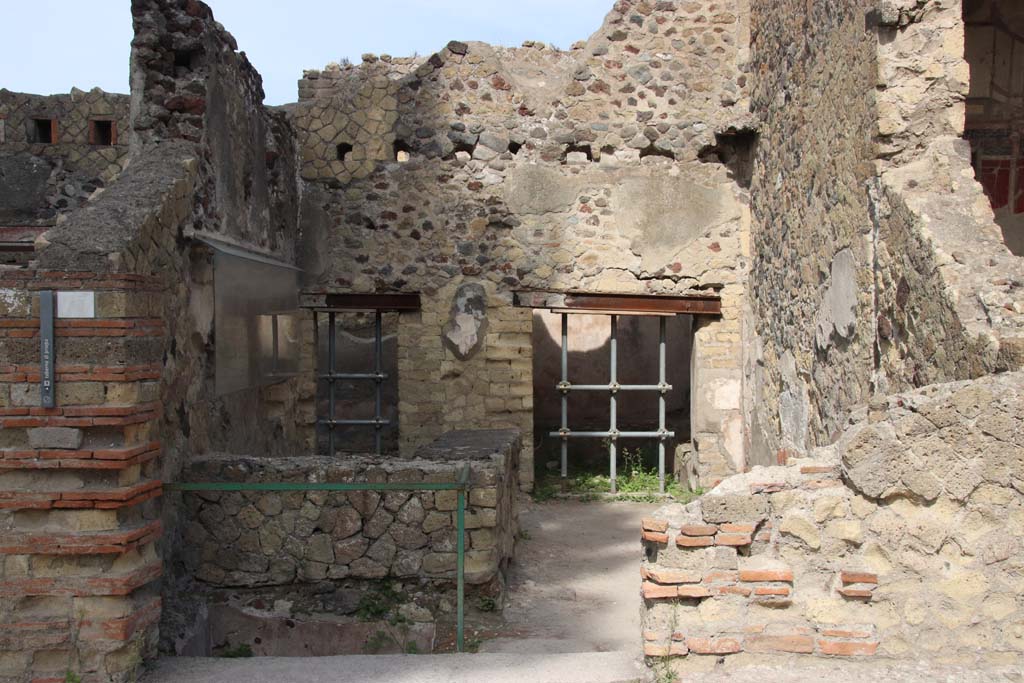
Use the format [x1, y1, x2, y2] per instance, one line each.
[124, 0, 298, 260]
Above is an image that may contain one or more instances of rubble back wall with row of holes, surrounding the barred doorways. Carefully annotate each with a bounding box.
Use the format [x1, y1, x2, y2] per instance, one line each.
[289, 1, 749, 487]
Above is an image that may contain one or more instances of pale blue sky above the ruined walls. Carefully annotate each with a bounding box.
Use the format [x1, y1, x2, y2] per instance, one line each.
[0, 0, 613, 104]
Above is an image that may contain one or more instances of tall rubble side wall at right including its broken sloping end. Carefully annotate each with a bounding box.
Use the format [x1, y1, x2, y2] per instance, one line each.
[746, 0, 1024, 464]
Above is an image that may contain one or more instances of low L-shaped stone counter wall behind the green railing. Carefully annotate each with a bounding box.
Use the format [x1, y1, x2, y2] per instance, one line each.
[161, 430, 522, 655]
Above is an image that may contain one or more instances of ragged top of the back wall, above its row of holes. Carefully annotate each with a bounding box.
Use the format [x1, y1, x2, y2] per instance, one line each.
[290, 0, 749, 184]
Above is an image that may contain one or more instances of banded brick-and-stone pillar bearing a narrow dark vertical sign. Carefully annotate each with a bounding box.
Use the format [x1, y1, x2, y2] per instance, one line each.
[0, 270, 164, 683]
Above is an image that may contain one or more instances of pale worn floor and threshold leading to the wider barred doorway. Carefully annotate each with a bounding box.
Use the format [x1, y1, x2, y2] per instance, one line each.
[142, 498, 658, 683]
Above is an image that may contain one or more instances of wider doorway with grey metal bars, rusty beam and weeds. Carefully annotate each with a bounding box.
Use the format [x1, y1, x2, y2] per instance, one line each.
[517, 293, 719, 497]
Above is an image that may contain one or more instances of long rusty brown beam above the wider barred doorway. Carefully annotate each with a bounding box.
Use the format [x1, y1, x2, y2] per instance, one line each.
[515, 292, 722, 315]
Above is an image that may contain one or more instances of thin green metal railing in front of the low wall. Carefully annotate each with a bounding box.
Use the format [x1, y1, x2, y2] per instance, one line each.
[164, 464, 470, 652]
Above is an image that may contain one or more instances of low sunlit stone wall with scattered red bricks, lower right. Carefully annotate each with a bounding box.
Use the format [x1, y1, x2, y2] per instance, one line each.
[641, 373, 1024, 671]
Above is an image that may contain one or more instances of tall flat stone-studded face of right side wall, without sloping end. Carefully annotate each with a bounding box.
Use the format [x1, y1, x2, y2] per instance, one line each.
[751, 0, 877, 463]
